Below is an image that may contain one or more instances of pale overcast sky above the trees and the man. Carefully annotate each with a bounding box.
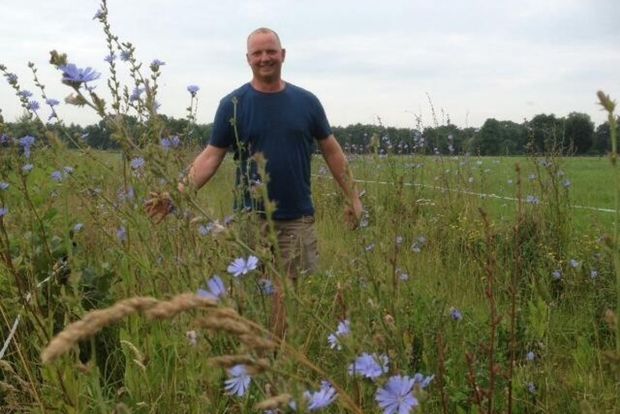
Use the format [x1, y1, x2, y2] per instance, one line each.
[0, 0, 620, 128]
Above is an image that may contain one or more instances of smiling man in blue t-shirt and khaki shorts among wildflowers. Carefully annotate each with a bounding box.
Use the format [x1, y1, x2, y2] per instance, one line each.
[179, 28, 362, 278]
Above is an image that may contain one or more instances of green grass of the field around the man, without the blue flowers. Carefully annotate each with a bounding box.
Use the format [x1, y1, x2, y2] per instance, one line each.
[0, 149, 620, 413]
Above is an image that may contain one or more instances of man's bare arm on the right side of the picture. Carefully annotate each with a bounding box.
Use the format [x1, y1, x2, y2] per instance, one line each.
[318, 135, 362, 228]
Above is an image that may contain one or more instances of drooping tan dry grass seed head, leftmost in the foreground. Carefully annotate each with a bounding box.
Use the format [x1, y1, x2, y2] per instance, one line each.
[41, 297, 158, 363]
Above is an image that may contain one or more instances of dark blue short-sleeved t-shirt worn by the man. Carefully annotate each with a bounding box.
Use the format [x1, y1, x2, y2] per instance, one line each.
[210, 83, 332, 220]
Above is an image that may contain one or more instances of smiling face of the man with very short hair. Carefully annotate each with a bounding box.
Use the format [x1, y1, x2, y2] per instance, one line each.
[246, 32, 286, 83]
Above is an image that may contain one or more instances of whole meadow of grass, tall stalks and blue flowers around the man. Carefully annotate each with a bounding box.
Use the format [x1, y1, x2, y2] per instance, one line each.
[0, 1, 620, 414]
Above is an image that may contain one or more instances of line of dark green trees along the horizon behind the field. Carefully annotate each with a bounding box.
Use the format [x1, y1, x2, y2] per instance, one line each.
[4, 112, 611, 155]
